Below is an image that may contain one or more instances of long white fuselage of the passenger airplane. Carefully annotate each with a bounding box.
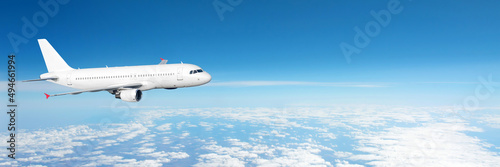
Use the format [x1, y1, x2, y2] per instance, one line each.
[40, 64, 212, 91]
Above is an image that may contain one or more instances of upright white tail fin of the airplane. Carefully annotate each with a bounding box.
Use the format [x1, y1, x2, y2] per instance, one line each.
[38, 39, 73, 72]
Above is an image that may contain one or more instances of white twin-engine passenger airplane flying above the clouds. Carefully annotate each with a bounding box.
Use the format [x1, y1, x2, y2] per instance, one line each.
[23, 39, 212, 102]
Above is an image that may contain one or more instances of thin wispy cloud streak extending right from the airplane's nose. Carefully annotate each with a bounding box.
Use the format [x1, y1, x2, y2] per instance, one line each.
[208, 81, 394, 88]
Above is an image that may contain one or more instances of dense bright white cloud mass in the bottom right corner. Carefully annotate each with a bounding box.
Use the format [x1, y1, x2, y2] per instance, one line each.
[349, 123, 500, 166]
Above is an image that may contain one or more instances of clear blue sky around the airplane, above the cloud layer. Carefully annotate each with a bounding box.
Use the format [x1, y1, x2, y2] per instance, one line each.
[0, 0, 500, 110]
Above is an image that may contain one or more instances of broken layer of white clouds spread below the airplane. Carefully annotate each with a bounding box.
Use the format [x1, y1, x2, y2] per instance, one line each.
[0, 106, 500, 166]
